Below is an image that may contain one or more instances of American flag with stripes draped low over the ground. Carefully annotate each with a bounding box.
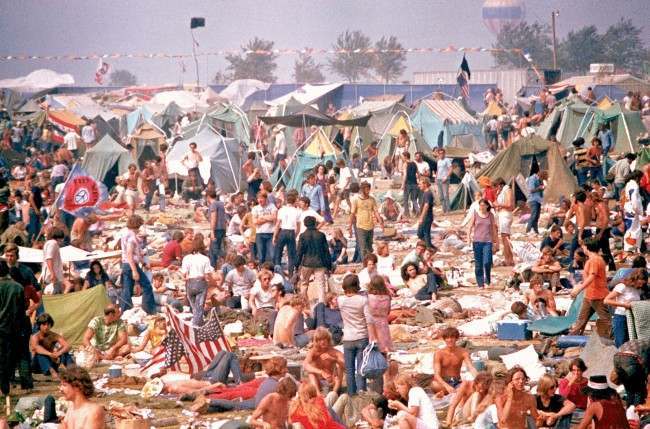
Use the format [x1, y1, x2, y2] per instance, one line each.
[142, 306, 230, 374]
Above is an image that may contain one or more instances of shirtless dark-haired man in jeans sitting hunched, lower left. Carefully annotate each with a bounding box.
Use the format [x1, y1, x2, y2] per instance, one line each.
[29, 313, 73, 380]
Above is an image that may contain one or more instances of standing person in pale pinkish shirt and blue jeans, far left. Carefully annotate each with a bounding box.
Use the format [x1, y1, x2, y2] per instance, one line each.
[120, 215, 156, 314]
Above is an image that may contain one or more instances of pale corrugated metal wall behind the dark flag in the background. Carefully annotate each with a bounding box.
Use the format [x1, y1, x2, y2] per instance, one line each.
[413, 69, 527, 103]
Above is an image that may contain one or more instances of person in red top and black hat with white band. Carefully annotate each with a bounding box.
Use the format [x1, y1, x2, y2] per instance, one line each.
[578, 375, 630, 429]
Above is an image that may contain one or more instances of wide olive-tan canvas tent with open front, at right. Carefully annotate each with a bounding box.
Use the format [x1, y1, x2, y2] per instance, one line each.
[477, 135, 578, 202]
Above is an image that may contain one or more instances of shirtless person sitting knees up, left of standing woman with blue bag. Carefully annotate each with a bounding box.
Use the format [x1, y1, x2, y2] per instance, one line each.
[303, 327, 345, 392]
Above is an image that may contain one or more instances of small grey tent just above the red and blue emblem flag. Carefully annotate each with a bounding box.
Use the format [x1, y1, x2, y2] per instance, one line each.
[81, 134, 135, 189]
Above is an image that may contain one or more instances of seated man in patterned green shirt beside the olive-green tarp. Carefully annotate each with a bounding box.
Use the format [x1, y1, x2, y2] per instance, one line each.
[83, 304, 131, 360]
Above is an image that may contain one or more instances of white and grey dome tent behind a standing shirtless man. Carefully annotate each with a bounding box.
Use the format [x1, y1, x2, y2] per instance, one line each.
[167, 126, 242, 192]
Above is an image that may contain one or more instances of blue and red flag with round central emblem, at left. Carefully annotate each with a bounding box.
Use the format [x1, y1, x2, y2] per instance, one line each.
[56, 164, 108, 217]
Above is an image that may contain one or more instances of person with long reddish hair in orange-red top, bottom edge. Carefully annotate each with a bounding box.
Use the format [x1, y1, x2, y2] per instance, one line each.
[289, 381, 345, 429]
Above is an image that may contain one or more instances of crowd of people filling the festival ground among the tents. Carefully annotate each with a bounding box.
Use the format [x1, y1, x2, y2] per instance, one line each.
[0, 83, 650, 429]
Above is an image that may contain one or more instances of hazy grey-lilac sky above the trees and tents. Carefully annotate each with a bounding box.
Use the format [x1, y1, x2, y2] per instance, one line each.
[0, 0, 650, 85]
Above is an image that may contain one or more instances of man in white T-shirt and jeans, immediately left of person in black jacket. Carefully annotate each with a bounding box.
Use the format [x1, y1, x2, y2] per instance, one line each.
[273, 192, 301, 276]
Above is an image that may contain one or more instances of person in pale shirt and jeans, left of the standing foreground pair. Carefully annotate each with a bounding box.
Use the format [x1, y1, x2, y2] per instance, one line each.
[337, 274, 368, 396]
